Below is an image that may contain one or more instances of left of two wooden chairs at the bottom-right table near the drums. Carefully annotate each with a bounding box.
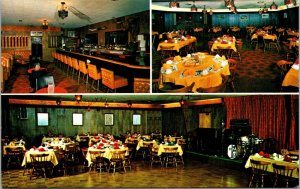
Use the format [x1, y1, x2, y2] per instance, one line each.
[249, 159, 272, 188]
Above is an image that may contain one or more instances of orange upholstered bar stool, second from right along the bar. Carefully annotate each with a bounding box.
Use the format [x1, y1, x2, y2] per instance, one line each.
[101, 68, 128, 92]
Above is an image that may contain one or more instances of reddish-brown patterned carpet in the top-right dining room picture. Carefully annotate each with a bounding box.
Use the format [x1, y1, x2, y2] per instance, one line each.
[152, 36, 298, 93]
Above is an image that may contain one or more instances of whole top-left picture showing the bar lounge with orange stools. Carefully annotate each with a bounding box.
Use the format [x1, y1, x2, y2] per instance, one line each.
[1, 0, 150, 93]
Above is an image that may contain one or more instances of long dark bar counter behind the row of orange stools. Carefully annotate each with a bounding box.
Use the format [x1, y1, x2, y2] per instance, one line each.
[57, 49, 150, 92]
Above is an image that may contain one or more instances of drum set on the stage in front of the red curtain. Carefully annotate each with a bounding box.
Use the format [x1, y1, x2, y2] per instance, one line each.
[227, 134, 264, 159]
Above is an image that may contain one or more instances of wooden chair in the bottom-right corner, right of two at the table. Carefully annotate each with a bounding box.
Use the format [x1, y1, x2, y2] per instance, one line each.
[272, 163, 297, 188]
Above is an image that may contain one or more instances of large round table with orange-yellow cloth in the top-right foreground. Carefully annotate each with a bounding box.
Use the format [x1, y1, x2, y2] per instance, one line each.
[160, 55, 230, 92]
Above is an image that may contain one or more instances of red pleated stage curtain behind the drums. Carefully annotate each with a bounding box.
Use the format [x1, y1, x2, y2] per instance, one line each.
[224, 95, 298, 150]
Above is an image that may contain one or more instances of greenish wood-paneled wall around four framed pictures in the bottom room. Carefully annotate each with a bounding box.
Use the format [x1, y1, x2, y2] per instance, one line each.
[2, 106, 162, 146]
